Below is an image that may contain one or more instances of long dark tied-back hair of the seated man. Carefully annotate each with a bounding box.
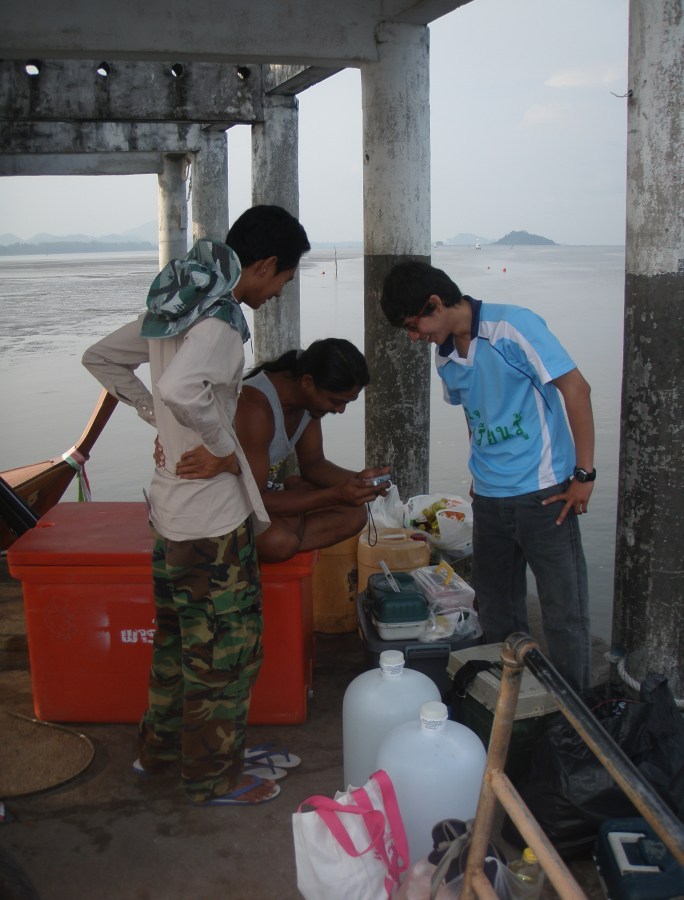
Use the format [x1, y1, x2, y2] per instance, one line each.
[245, 338, 370, 391]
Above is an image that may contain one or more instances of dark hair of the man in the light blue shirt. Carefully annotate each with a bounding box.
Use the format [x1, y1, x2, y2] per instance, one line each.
[380, 261, 463, 326]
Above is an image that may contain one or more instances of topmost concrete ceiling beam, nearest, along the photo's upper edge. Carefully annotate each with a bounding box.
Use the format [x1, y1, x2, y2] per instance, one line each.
[0, 0, 467, 68]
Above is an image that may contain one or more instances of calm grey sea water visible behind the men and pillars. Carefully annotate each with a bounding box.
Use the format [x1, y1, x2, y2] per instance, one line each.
[0, 245, 624, 639]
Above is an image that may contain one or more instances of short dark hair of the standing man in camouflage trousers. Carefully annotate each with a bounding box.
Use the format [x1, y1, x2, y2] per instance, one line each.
[226, 205, 311, 272]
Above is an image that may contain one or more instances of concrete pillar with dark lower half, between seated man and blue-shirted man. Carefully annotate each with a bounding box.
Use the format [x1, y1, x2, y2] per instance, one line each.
[361, 24, 431, 499]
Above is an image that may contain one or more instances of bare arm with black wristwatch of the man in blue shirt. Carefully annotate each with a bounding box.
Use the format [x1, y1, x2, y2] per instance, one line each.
[544, 369, 594, 525]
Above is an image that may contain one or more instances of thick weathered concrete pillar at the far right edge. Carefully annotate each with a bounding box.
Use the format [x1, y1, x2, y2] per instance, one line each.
[616, 0, 684, 697]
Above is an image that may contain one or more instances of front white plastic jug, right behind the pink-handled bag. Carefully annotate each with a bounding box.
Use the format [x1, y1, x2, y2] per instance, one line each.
[376, 703, 487, 863]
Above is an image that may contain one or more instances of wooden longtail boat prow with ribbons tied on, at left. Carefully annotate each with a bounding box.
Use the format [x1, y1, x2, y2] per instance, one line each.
[0, 391, 119, 550]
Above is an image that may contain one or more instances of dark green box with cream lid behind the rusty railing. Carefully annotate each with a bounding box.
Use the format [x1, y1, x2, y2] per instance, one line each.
[447, 643, 561, 781]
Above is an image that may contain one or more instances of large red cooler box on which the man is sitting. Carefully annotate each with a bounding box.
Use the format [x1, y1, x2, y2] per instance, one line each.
[7, 503, 315, 724]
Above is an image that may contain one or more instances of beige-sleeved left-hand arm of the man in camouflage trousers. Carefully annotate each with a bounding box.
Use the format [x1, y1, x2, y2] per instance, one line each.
[82, 318, 155, 425]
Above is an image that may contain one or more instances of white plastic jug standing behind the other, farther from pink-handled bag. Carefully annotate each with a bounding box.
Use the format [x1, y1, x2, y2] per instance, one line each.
[342, 650, 440, 788]
